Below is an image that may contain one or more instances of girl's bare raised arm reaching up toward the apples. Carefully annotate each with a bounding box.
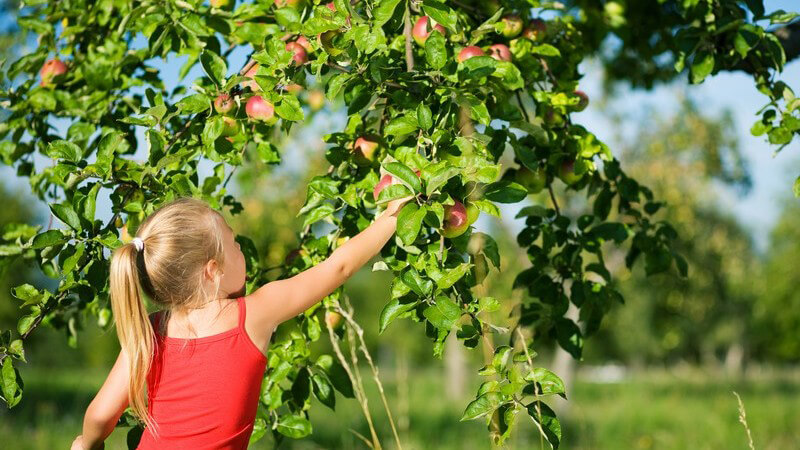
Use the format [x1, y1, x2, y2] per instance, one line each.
[248, 197, 412, 330]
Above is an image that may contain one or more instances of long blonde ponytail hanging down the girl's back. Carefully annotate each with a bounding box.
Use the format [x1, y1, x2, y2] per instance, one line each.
[110, 243, 157, 435]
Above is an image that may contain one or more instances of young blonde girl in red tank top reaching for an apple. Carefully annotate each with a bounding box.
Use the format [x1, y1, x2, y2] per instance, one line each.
[72, 197, 411, 450]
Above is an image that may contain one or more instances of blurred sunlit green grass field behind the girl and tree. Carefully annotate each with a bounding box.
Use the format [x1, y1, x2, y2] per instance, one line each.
[0, 367, 800, 450]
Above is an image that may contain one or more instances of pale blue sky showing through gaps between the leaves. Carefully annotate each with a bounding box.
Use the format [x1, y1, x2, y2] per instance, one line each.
[0, 0, 800, 248]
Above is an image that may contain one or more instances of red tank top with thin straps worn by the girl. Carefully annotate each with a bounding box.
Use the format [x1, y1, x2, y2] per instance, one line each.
[137, 297, 267, 450]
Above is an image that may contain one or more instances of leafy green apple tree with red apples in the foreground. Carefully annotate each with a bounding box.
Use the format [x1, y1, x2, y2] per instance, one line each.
[0, 0, 800, 448]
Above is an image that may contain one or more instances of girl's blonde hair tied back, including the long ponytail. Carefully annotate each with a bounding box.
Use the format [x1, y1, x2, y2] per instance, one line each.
[110, 197, 230, 436]
